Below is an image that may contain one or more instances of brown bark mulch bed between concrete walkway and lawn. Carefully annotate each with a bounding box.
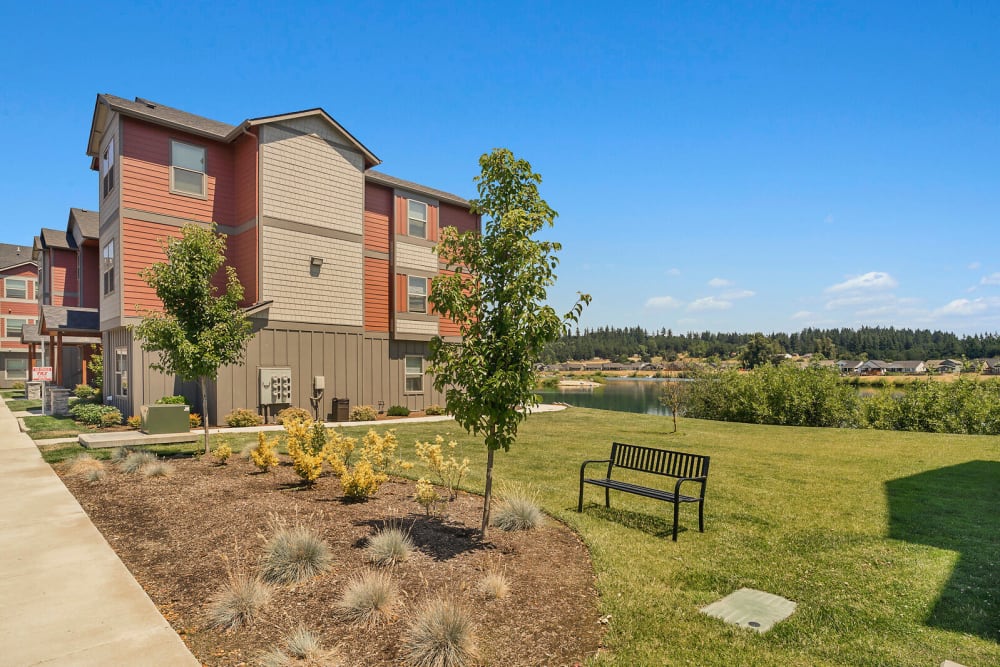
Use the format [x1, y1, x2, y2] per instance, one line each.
[56, 457, 603, 666]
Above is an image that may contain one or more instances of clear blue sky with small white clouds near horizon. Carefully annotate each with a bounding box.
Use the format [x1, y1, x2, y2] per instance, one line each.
[0, 2, 1000, 333]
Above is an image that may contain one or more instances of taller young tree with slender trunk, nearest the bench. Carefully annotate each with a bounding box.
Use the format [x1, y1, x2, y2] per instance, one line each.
[429, 148, 590, 537]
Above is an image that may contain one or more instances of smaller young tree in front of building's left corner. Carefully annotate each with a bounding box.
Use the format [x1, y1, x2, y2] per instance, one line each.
[135, 225, 253, 454]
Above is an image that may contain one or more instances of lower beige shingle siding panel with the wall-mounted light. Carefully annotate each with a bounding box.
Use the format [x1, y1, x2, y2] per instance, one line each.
[262, 226, 363, 327]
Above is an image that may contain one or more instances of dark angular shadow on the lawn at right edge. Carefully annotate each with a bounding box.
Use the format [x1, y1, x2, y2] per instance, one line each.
[885, 461, 1000, 641]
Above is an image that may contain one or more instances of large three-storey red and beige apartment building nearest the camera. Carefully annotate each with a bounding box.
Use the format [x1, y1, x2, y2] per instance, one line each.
[81, 95, 479, 423]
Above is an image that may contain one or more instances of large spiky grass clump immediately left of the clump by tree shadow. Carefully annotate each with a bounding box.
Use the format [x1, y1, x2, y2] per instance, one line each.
[260, 518, 333, 584]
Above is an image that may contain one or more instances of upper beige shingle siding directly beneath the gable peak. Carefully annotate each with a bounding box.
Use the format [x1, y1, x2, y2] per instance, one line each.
[261, 118, 364, 234]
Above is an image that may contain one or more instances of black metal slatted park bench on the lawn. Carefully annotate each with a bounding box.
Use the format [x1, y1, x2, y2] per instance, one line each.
[576, 442, 709, 542]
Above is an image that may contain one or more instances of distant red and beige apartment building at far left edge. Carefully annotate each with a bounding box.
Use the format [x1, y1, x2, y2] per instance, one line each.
[0, 243, 38, 388]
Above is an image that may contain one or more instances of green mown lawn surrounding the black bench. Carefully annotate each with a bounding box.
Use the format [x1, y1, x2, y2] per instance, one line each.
[43, 408, 1000, 667]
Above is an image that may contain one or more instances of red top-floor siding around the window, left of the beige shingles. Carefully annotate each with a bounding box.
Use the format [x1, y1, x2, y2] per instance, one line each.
[121, 118, 236, 225]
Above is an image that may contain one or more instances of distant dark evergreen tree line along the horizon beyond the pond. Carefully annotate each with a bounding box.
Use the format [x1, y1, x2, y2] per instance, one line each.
[542, 327, 1000, 363]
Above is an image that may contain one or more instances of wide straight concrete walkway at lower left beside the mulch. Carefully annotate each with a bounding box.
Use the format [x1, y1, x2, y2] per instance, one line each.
[0, 401, 200, 667]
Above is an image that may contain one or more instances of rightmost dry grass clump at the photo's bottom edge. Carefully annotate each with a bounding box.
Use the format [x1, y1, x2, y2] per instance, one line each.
[403, 599, 479, 667]
